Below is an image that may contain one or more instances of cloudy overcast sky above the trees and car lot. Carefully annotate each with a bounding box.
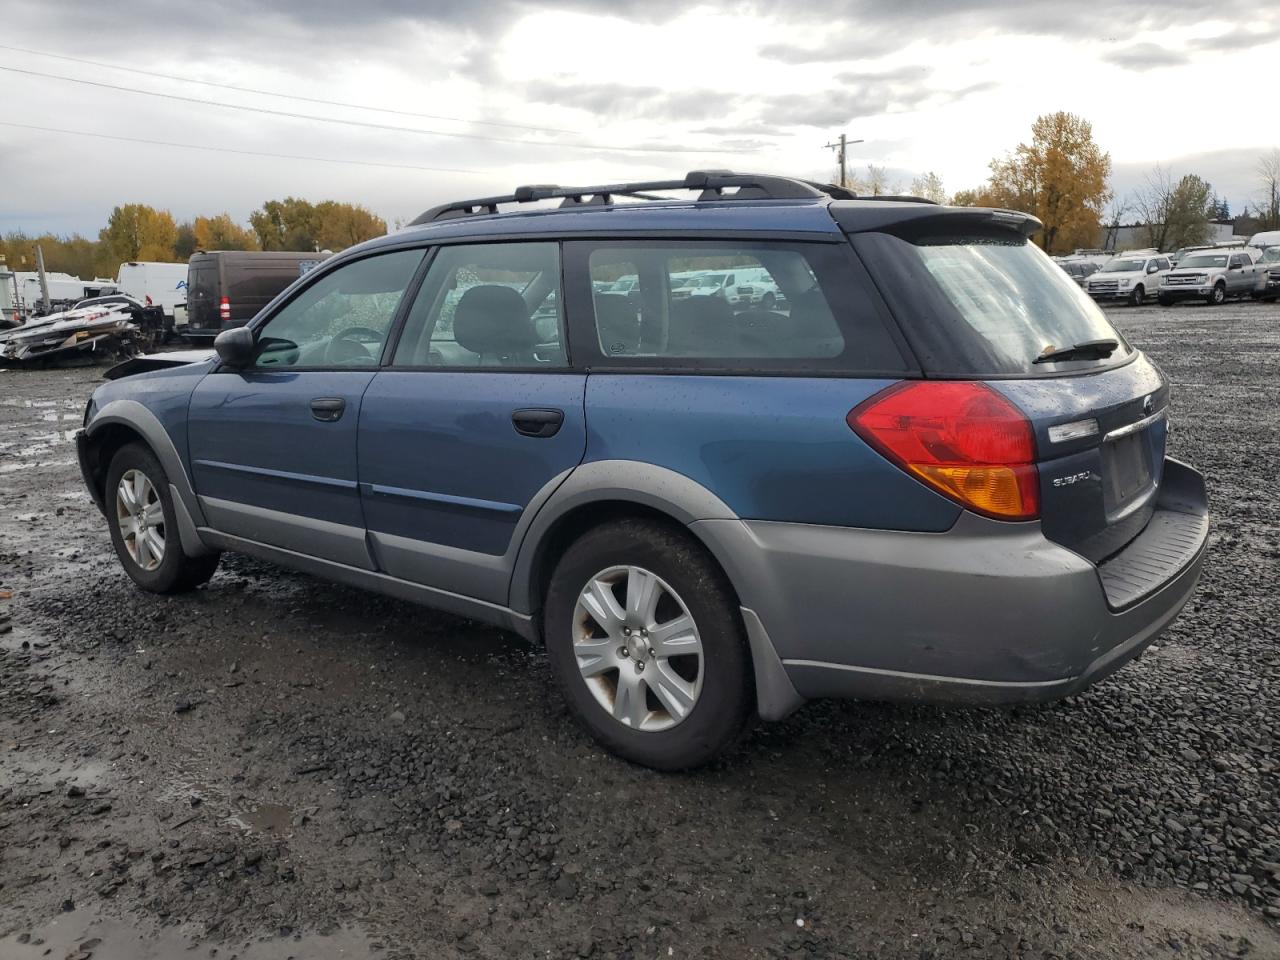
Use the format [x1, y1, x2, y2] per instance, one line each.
[0, 0, 1280, 236]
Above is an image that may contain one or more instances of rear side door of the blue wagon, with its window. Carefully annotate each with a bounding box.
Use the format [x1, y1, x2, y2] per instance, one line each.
[360, 242, 586, 603]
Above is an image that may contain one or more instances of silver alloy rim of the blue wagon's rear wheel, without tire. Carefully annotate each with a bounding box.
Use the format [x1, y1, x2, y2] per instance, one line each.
[573, 566, 704, 731]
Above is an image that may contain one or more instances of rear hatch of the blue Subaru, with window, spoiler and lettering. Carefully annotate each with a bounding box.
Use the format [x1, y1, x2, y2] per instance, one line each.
[832, 204, 1169, 563]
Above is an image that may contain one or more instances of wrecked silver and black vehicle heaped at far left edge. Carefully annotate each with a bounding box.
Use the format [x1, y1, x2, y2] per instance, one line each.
[0, 297, 163, 366]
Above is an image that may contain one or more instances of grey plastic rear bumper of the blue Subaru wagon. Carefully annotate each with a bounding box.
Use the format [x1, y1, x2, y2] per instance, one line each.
[692, 460, 1208, 703]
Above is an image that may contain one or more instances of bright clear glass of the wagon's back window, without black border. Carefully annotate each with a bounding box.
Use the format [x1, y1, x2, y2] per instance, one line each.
[910, 237, 1126, 374]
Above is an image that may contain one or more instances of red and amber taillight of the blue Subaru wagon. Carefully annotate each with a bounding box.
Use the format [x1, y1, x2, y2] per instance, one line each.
[847, 380, 1039, 520]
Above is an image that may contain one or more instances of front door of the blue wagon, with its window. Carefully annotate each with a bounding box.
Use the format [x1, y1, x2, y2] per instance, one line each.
[188, 250, 422, 570]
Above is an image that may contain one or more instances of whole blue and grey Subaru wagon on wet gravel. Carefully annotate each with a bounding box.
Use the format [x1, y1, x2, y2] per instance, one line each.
[78, 172, 1208, 769]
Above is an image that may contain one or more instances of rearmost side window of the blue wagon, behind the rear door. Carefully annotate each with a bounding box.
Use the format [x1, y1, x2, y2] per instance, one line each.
[575, 241, 906, 372]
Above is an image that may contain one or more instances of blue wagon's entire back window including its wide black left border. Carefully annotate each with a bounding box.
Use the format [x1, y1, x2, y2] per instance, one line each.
[854, 233, 1130, 376]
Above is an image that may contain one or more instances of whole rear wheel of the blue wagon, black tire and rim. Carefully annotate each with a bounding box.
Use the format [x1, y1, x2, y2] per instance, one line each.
[543, 520, 755, 771]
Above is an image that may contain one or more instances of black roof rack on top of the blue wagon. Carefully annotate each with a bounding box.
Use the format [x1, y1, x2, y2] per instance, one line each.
[410, 170, 858, 227]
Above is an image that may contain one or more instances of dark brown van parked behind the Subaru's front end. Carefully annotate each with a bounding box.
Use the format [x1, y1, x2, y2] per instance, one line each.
[184, 250, 329, 339]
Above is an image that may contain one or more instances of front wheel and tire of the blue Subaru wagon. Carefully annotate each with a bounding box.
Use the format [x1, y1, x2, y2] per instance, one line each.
[104, 443, 220, 594]
